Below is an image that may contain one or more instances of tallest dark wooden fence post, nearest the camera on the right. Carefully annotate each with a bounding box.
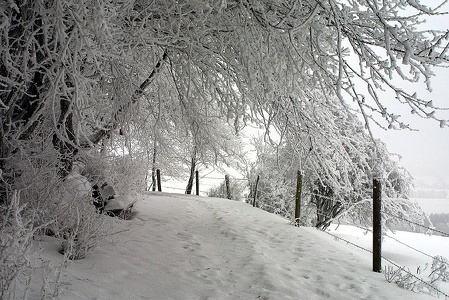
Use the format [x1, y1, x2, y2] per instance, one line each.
[373, 178, 382, 273]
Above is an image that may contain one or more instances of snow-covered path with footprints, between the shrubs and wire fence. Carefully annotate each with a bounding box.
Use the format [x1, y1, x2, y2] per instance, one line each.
[32, 193, 448, 300]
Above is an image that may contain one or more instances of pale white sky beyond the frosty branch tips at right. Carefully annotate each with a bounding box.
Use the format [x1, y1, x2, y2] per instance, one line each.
[373, 4, 449, 189]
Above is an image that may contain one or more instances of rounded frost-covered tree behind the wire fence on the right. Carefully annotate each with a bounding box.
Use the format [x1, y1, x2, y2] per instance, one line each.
[248, 93, 423, 228]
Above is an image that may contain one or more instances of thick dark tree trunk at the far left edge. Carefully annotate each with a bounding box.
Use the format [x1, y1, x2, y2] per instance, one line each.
[0, 1, 48, 203]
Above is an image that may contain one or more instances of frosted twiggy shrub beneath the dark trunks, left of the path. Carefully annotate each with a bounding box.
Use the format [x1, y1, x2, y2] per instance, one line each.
[2, 143, 112, 259]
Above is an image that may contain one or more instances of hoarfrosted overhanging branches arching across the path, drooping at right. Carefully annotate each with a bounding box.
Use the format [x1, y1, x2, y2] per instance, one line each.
[0, 0, 449, 270]
